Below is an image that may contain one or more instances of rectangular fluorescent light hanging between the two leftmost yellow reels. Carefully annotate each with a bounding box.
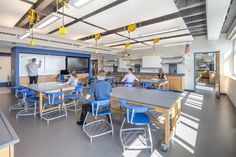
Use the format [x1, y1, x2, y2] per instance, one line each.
[34, 12, 62, 29]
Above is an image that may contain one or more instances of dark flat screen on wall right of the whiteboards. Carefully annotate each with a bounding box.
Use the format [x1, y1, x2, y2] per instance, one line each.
[66, 57, 89, 73]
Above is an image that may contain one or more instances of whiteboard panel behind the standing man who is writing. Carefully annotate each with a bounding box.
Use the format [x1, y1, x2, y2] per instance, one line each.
[19, 53, 45, 76]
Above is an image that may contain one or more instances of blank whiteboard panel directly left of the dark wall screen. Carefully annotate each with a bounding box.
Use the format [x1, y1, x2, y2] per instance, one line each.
[45, 56, 66, 75]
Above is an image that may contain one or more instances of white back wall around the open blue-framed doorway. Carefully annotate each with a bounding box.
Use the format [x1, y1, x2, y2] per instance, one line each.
[127, 34, 232, 93]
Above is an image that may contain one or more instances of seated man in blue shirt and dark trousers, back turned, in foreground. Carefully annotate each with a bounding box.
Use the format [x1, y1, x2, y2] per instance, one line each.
[77, 70, 112, 125]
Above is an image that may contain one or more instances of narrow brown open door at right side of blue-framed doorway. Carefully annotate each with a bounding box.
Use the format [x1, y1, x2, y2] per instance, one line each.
[215, 52, 220, 98]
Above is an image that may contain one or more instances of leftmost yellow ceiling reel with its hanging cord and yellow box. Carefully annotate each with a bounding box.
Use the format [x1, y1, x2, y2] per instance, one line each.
[28, 9, 40, 46]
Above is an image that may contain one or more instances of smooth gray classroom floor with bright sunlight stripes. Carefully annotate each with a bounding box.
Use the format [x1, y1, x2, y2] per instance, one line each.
[0, 91, 236, 157]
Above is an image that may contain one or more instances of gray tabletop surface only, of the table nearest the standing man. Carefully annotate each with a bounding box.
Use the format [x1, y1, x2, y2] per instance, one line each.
[25, 82, 74, 92]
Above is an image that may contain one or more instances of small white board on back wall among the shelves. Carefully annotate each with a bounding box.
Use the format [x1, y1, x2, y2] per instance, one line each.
[142, 56, 162, 68]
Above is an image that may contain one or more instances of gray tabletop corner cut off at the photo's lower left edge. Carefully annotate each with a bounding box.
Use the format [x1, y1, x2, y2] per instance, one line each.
[0, 111, 20, 149]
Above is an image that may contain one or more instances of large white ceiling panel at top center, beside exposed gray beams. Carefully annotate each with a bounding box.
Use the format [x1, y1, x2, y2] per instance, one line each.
[85, 0, 178, 29]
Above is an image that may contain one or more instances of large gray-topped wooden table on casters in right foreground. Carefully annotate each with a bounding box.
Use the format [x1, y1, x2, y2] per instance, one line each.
[111, 87, 181, 149]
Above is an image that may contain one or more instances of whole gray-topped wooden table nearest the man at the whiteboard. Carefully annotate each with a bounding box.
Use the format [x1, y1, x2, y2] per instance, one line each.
[24, 82, 75, 118]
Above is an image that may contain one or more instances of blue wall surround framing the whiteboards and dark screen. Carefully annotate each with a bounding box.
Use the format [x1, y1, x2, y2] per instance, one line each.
[11, 47, 92, 86]
